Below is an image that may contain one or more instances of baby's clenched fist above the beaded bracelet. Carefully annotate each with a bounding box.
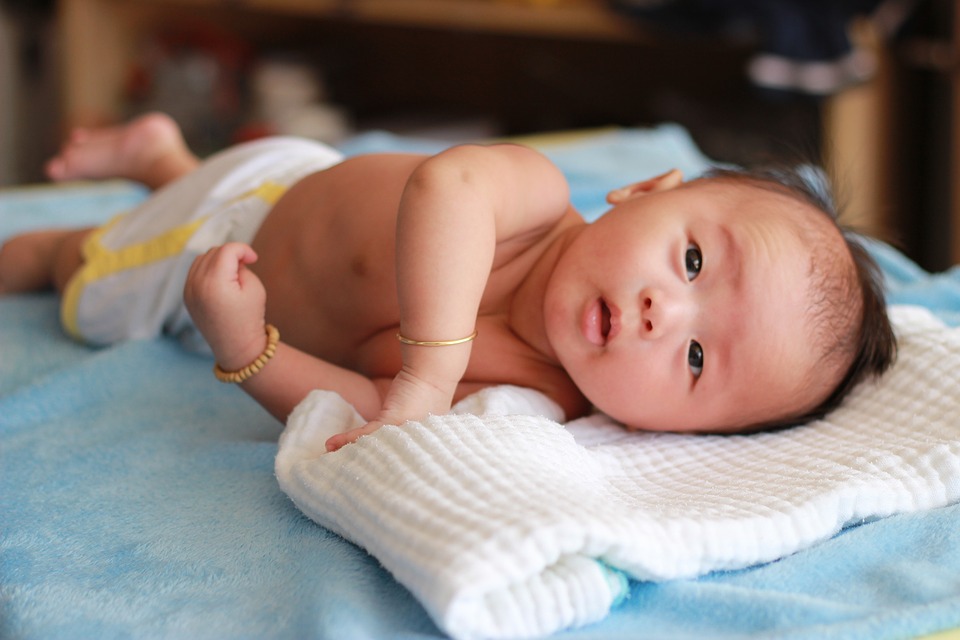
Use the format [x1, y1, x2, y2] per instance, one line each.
[183, 242, 267, 371]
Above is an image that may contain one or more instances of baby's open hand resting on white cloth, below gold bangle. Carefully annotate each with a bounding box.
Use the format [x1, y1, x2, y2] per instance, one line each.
[327, 370, 456, 451]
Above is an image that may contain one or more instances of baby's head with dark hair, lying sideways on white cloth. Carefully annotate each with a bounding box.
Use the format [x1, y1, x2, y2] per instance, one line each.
[545, 165, 896, 432]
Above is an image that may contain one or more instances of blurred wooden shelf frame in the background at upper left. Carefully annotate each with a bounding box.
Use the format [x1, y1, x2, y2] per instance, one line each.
[58, 0, 643, 127]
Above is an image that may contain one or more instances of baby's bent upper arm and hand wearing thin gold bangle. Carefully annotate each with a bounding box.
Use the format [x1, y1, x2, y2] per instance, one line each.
[327, 145, 569, 449]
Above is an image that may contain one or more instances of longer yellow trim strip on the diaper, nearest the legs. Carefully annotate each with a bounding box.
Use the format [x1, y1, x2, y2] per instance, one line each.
[60, 216, 207, 339]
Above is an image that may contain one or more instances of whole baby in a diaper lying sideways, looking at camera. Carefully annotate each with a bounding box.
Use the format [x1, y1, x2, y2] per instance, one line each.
[0, 114, 896, 450]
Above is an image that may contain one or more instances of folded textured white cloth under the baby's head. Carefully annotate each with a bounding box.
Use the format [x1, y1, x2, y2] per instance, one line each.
[276, 307, 960, 638]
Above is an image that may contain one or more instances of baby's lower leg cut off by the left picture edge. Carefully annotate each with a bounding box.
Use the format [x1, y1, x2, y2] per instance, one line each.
[0, 229, 91, 295]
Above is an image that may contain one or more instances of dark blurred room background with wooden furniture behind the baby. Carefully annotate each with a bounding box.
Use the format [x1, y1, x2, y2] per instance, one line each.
[0, 0, 960, 270]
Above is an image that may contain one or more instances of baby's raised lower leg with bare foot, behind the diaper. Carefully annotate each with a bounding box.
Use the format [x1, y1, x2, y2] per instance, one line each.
[46, 113, 199, 189]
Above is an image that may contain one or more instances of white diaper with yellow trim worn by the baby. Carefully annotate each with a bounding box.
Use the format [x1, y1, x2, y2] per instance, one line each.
[61, 137, 342, 350]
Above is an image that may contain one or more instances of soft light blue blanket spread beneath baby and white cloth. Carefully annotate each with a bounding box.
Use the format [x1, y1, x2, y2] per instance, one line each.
[0, 126, 960, 639]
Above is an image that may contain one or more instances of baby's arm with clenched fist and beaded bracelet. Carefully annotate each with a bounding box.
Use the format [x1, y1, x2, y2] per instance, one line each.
[184, 243, 386, 422]
